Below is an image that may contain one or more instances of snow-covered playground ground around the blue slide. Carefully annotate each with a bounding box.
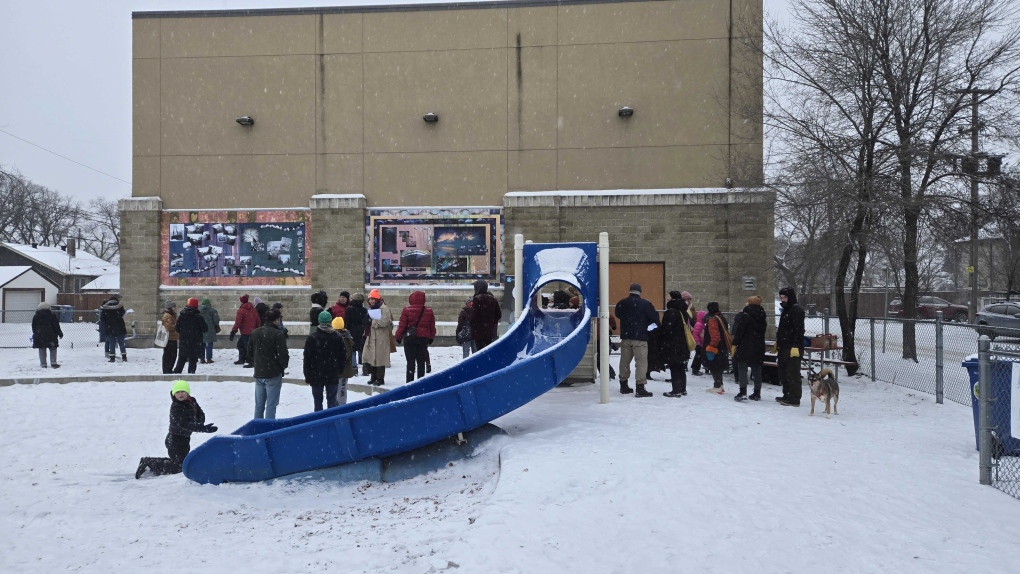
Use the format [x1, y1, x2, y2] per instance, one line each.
[0, 348, 1020, 574]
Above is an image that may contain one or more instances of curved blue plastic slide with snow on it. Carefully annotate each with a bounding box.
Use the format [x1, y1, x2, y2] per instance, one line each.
[184, 243, 599, 484]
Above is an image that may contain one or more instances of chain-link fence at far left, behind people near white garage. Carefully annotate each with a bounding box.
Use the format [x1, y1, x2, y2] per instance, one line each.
[0, 305, 135, 349]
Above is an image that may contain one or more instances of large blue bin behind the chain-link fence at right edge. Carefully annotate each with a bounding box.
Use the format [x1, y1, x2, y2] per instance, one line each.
[963, 357, 1020, 458]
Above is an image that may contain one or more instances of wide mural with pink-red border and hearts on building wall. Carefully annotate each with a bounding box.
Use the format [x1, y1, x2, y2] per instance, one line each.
[159, 210, 311, 286]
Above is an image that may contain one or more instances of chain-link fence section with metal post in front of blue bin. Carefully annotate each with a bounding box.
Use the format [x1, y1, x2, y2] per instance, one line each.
[971, 338, 1020, 499]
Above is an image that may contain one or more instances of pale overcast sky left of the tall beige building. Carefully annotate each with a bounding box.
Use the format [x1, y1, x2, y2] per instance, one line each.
[0, 0, 786, 200]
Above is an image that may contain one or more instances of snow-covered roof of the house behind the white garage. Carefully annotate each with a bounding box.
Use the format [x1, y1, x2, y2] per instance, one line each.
[0, 243, 119, 293]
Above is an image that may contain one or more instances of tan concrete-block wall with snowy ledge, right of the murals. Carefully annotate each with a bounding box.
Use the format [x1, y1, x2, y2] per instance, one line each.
[504, 190, 776, 311]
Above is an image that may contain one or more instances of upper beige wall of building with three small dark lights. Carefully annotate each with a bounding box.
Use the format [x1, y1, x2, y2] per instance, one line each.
[133, 0, 762, 209]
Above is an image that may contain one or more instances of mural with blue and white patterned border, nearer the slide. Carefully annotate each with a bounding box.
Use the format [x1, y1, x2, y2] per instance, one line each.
[365, 208, 504, 285]
